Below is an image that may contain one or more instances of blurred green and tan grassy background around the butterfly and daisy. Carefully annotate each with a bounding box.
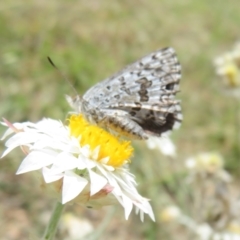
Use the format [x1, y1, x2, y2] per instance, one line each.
[0, 0, 240, 239]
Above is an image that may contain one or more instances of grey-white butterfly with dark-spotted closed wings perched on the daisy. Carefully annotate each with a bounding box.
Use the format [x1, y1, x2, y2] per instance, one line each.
[67, 47, 183, 139]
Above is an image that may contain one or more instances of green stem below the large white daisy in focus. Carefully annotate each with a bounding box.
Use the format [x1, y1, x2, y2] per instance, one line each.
[42, 202, 65, 240]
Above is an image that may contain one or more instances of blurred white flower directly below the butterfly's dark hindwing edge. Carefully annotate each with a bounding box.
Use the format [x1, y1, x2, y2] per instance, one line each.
[146, 135, 176, 157]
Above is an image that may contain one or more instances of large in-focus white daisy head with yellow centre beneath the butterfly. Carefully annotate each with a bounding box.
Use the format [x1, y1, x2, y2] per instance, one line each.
[1, 115, 155, 221]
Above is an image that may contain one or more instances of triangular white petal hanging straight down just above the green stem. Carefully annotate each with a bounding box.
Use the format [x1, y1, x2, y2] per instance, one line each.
[62, 171, 88, 204]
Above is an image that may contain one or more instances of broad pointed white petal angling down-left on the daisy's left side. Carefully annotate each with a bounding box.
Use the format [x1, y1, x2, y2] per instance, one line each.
[16, 149, 57, 174]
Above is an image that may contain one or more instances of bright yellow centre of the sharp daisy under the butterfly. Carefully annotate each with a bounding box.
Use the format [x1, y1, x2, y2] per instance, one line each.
[69, 114, 133, 167]
